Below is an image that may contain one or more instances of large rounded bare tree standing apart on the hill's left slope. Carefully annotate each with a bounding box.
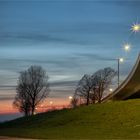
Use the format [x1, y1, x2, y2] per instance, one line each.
[13, 66, 50, 116]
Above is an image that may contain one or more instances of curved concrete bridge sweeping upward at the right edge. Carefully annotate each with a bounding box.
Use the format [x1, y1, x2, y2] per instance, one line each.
[102, 54, 140, 102]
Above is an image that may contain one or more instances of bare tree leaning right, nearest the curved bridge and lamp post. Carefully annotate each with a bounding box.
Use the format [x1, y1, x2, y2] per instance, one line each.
[91, 67, 116, 103]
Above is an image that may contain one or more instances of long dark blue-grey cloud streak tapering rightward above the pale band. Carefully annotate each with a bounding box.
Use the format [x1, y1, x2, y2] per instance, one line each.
[0, 32, 89, 45]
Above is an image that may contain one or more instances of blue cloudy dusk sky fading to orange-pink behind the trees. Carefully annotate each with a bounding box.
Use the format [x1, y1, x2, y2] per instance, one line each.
[0, 0, 140, 121]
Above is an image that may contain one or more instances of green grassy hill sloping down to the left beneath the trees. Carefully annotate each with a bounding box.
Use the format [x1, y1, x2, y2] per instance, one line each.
[0, 100, 140, 140]
